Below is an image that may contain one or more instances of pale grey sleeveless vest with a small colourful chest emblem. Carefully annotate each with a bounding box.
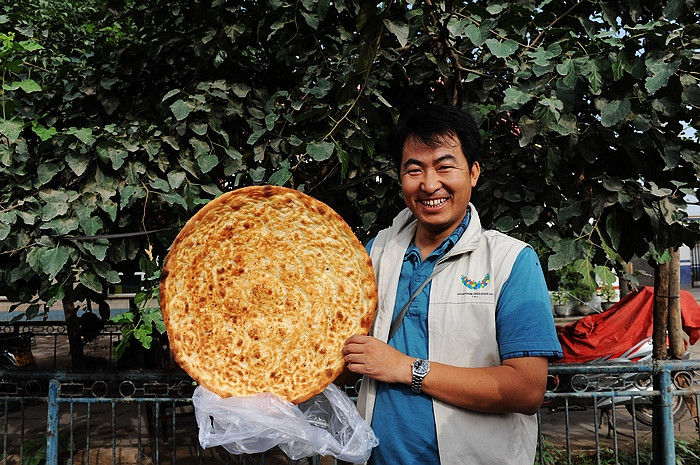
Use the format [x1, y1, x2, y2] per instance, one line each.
[357, 204, 537, 465]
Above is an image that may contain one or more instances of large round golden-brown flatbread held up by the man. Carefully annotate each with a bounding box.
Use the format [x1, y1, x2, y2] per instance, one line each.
[160, 186, 377, 403]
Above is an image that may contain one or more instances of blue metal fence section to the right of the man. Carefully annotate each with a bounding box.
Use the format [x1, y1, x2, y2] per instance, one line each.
[538, 360, 700, 465]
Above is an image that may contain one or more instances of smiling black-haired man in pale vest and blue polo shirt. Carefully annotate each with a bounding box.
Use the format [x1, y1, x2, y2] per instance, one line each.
[343, 105, 561, 465]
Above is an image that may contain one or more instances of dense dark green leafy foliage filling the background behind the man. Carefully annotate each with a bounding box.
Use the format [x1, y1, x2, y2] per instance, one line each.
[0, 0, 700, 363]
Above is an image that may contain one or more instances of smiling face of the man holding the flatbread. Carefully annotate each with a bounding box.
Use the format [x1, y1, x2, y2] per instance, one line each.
[401, 134, 481, 239]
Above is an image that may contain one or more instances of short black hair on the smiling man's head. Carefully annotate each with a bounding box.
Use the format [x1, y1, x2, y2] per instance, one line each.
[387, 104, 482, 172]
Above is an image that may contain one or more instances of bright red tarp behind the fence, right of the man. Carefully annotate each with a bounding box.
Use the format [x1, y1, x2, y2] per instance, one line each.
[557, 287, 700, 363]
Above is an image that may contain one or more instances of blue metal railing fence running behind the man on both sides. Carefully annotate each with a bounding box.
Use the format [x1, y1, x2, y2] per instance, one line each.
[0, 326, 700, 465]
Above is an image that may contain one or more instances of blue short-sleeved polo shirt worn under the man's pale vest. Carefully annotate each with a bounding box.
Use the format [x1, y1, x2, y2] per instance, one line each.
[367, 212, 562, 465]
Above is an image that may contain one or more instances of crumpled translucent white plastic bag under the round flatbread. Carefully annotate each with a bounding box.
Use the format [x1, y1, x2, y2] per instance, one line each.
[192, 384, 378, 463]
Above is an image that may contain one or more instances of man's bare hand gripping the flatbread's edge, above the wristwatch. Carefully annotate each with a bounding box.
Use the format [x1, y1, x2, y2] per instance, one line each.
[343, 334, 415, 384]
